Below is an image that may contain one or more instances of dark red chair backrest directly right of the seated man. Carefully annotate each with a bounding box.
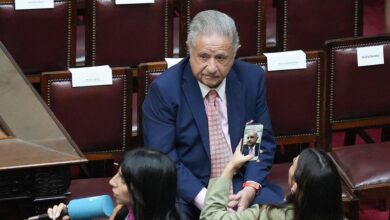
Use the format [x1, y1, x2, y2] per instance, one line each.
[240, 51, 327, 147]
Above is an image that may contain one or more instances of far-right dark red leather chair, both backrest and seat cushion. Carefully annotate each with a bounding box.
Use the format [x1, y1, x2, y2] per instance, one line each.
[326, 35, 390, 219]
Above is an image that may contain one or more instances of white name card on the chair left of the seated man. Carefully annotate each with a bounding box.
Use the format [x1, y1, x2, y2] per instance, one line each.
[69, 65, 112, 87]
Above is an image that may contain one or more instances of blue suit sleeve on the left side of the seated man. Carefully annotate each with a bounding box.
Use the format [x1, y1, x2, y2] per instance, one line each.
[142, 81, 203, 203]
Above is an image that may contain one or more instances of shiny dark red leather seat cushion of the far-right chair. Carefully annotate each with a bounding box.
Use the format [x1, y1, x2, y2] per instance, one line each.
[330, 142, 390, 191]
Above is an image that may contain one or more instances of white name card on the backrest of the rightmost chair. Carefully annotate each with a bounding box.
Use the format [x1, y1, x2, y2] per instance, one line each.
[356, 45, 385, 66]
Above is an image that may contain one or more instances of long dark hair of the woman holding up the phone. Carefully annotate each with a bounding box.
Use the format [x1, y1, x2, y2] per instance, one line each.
[287, 148, 343, 220]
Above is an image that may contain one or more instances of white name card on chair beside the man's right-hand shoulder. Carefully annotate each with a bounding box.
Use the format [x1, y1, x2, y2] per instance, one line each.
[264, 50, 306, 71]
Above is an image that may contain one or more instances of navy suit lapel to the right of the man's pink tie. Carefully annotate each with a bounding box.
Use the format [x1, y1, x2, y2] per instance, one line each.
[226, 69, 245, 152]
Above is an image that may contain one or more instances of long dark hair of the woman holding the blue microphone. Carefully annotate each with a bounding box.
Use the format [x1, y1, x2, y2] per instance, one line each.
[115, 148, 179, 220]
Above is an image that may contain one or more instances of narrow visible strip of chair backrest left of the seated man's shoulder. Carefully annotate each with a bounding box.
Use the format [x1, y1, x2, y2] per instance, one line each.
[137, 61, 168, 144]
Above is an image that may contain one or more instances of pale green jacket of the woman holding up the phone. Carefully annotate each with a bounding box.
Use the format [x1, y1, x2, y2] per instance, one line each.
[200, 178, 294, 220]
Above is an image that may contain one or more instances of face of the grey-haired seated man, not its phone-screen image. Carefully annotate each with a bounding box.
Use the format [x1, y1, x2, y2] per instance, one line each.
[190, 34, 234, 88]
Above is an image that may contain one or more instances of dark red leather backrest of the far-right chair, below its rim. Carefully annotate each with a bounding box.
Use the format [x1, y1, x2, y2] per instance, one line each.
[326, 35, 390, 134]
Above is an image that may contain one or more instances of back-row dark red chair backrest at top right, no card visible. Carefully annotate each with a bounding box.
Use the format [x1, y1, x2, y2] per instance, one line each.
[277, 0, 363, 50]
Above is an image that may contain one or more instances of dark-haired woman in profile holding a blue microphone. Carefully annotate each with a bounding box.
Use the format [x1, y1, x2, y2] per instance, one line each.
[47, 148, 179, 220]
